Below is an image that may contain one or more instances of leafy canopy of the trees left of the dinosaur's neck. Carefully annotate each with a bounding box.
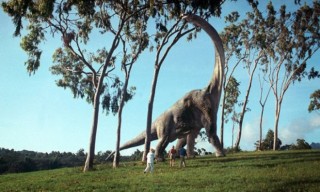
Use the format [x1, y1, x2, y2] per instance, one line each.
[2, 0, 222, 118]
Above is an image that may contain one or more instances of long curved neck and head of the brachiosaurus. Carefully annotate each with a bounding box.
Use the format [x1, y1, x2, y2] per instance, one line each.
[183, 14, 225, 103]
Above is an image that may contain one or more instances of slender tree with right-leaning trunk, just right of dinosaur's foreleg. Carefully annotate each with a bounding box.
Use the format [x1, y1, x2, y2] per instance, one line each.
[223, 2, 266, 148]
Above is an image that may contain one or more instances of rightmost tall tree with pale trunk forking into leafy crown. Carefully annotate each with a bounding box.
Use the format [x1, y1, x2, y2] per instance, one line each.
[266, 1, 320, 150]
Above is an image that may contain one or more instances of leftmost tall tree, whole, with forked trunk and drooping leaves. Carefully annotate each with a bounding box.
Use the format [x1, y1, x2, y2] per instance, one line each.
[2, 0, 148, 171]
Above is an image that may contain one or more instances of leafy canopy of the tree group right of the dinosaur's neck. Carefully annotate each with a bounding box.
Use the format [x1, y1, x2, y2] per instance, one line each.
[222, 2, 320, 84]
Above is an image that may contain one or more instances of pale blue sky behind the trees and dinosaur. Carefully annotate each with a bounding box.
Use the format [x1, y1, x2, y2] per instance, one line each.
[0, 0, 320, 155]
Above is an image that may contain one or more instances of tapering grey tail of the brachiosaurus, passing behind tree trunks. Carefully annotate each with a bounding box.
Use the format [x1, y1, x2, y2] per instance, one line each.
[106, 129, 158, 161]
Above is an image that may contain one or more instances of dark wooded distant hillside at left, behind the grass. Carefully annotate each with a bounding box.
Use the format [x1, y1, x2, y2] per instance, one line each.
[0, 147, 142, 174]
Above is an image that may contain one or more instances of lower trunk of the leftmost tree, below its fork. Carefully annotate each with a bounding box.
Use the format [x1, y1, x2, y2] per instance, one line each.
[83, 92, 100, 172]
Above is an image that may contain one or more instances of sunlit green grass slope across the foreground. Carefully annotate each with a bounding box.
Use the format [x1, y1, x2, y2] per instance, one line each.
[0, 150, 320, 192]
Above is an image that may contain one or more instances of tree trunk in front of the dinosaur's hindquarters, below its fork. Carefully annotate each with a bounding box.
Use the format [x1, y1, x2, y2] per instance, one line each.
[142, 65, 160, 162]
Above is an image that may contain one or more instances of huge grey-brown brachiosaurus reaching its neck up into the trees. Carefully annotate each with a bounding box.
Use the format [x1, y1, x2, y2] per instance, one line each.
[110, 14, 225, 160]
